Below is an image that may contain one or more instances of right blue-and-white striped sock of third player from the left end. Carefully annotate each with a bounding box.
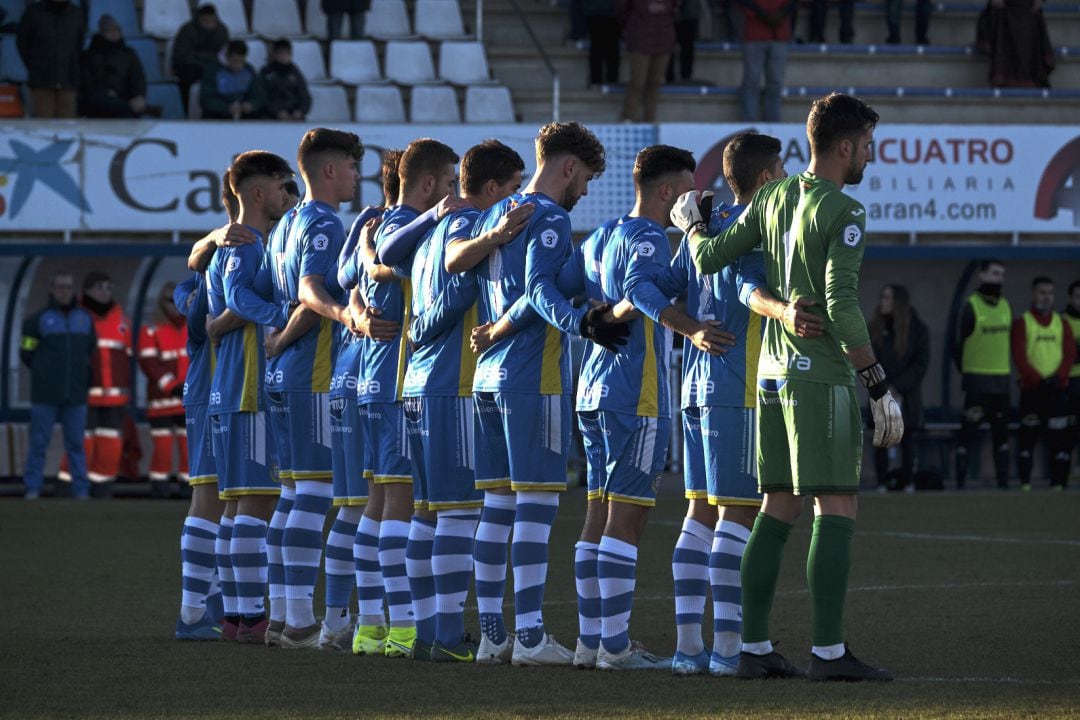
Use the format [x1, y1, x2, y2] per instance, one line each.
[282, 480, 334, 627]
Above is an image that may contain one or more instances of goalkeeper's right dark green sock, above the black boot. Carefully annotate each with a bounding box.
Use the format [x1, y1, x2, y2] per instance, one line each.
[807, 515, 855, 647]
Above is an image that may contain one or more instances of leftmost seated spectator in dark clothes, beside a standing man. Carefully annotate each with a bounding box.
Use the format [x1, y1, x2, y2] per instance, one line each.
[79, 15, 151, 118]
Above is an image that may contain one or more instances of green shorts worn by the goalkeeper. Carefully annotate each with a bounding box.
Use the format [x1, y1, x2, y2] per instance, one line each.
[757, 378, 863, 495]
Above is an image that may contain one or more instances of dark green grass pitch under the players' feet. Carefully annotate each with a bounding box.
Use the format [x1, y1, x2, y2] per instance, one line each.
[0, 483, 1080, 720]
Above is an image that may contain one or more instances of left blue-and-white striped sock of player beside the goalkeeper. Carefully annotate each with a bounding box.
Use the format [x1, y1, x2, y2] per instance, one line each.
[672, 517, 713, 655]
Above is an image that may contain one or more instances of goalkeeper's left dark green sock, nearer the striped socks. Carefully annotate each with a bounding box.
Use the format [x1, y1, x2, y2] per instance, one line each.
[741, 513, 792, 642]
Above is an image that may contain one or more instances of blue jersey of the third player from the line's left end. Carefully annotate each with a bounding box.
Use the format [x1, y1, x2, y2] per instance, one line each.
[267, 200, 345, 393]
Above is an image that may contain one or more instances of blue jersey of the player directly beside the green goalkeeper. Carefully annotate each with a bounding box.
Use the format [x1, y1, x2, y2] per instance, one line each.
[671, 205, 766, 408]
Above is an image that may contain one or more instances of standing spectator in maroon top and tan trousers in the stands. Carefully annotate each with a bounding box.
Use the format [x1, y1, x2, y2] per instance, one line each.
[615, 0, 678, 122]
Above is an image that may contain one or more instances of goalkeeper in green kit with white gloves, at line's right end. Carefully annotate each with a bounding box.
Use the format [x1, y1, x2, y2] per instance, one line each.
[672, 93, 904, 680]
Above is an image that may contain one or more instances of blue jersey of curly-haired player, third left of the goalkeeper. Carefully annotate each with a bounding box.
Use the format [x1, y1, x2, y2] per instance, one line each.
[473, 193, 586, 395]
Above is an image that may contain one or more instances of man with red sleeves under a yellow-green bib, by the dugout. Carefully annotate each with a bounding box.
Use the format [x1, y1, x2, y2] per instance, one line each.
[1011, 276, 1076, 490]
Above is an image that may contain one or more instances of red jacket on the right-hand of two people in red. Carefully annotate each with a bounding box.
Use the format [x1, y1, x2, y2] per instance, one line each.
[138, 317, 188, 418]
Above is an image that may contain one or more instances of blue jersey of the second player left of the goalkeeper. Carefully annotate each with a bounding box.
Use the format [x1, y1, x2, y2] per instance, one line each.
[578, 217, 672, 418]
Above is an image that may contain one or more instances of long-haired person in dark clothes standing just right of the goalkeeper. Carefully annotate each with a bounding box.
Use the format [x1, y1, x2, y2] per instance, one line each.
[869, 285, 930, 492]
